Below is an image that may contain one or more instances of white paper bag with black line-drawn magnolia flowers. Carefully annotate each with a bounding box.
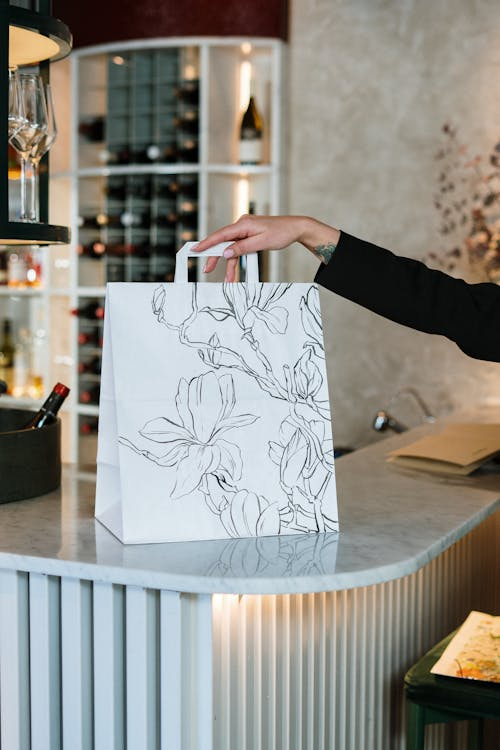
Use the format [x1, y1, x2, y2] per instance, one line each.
[95, 243, 338, 543]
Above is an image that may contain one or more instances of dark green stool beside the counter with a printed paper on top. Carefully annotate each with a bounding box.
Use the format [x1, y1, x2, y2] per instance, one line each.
[404, 633, 500, 750]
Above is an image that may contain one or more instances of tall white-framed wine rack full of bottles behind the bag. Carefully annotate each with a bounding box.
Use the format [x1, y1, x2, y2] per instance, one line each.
[50, 37, 285, 467]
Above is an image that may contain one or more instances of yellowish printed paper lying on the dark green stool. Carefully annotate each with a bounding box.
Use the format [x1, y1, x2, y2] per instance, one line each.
[431, 611, 500, 683]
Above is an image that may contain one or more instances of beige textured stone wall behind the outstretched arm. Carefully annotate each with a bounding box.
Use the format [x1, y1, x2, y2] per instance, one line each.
[287, 0, 500, 446]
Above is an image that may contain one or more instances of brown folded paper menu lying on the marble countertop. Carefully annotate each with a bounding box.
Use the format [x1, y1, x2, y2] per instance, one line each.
[387, 423, 500, 475]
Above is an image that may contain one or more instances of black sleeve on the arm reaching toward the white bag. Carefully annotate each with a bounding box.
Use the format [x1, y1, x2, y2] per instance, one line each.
[315, 232, 500, 362]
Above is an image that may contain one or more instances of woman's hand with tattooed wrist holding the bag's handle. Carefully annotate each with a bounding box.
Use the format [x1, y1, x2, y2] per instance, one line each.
[193, 214, 340, 281]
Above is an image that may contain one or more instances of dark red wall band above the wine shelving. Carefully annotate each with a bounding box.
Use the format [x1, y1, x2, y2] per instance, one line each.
[52, 0, 288, 47]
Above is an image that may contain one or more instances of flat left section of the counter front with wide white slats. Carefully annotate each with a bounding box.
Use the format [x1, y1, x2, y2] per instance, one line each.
[0, 571, 213, 750]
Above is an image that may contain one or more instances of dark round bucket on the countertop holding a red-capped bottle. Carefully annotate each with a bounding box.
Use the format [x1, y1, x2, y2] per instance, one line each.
[0, 408, 61, 503]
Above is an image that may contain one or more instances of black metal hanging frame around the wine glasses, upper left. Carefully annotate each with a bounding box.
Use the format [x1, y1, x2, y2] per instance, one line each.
[0, 0, 72, 245]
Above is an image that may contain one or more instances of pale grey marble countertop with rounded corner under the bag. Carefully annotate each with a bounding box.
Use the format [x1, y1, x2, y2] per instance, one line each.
[0, 408, 500, 594]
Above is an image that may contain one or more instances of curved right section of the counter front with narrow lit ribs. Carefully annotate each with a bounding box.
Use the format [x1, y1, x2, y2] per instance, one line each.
[214, 514, 500, 750]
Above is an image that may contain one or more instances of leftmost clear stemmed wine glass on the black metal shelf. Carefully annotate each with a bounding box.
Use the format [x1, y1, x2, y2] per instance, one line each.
[9, 74, 47, 221]
